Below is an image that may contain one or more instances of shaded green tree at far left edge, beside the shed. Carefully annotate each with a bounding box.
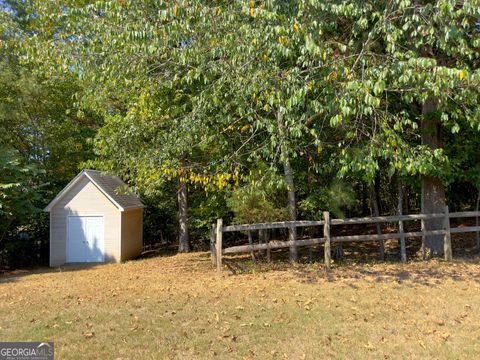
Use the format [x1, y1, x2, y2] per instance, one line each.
[0, 1, 99, 265]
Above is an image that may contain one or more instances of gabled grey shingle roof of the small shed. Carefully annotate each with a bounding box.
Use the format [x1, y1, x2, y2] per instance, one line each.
[44, 169, 144, 211]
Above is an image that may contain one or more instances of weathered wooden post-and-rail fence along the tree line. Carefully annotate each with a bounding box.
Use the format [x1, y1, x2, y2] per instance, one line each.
[210, 206, 480, 272]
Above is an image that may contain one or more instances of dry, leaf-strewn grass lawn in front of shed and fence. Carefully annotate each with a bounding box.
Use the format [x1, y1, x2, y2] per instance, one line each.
[0, 253, 480, 359]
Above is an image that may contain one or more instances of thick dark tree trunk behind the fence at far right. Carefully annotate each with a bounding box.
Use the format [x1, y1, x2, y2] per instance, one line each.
[421, 97, 445, 257]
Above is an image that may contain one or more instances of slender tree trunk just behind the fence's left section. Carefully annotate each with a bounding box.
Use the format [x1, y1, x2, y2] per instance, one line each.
[277, 111, 298, 262]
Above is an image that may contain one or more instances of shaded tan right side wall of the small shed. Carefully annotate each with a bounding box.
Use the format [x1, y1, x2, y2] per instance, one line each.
[121, 209, 143, 261]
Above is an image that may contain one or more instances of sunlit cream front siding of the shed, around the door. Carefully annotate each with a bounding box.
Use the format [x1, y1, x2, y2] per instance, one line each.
[50, 177, 121, 266]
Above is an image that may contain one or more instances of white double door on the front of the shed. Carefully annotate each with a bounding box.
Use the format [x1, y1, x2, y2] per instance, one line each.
[67, 216, 104, 262]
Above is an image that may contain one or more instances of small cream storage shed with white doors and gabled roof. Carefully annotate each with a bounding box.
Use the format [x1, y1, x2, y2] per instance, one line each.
[45, 170, 144, 266]
